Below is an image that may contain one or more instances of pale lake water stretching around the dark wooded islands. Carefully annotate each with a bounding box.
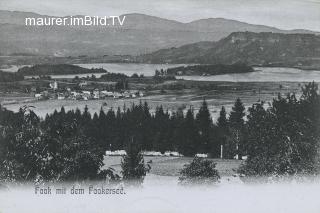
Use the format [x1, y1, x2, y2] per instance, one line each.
[9, 63, 320, 82]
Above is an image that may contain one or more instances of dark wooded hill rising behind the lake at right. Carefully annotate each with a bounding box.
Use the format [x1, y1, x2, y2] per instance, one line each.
[140, 32, 320, 68]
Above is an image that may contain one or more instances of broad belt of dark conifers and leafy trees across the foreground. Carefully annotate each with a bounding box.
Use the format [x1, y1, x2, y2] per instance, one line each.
[0, 83, 320, 180]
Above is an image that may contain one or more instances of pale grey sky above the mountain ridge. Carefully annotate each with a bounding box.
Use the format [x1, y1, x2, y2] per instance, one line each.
[0, 0, 320, 31]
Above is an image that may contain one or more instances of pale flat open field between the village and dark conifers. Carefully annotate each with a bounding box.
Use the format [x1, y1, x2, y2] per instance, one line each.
[0, 81, 303, 120]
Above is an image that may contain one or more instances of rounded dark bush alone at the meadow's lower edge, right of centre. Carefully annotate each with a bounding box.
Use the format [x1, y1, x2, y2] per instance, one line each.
[179, 157, 220, 185]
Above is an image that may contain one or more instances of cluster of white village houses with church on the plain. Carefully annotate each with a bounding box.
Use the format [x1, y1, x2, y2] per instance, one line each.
[31, 81, 144, 101]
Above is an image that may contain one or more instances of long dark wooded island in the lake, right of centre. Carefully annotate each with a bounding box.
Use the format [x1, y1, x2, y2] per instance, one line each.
[167, 63, 254, 75]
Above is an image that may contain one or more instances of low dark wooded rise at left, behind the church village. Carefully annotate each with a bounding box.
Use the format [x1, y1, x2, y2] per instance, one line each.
[18, 64, 107, 76]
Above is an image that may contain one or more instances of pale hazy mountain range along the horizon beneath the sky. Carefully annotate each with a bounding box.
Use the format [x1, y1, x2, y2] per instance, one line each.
[0, 10, 316, 57]
